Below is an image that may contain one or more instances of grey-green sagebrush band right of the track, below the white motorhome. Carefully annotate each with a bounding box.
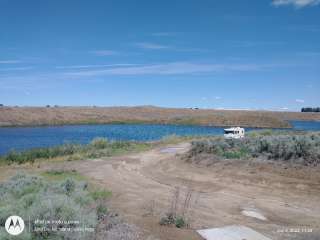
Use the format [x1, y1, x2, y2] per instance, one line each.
[188, 131, 320, 165]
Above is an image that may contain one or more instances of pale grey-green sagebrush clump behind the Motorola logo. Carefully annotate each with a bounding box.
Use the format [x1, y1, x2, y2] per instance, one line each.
[0, 174, 106, 240]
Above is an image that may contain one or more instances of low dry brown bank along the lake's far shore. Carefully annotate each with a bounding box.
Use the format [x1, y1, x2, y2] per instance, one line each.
[0, 106, 320, 128]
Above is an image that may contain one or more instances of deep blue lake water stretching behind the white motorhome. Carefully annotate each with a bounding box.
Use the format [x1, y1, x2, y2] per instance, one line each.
[0, 121, 320, 155]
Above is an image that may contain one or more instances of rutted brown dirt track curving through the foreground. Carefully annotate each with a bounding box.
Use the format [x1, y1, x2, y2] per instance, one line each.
[52, 143, 320, 240]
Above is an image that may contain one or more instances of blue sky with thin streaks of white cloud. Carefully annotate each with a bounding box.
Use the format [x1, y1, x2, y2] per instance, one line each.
[0, 0, 320, 111]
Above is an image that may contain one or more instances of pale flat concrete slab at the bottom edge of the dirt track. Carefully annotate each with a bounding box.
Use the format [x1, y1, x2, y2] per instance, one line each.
[197, 225, 271, 240]
